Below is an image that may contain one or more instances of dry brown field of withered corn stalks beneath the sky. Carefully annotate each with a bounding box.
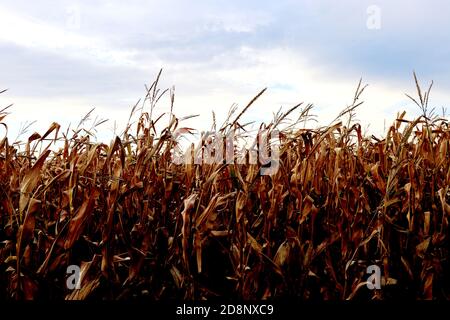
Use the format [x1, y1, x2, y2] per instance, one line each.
[0, 72, 450, 300]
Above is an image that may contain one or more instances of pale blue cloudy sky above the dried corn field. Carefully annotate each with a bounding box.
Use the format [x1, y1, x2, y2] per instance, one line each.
[0, 0, 450, 138]
